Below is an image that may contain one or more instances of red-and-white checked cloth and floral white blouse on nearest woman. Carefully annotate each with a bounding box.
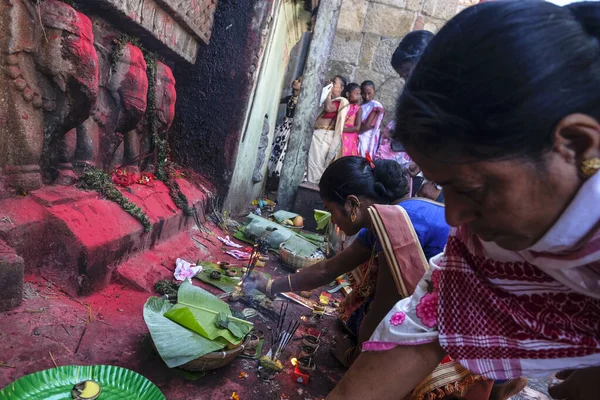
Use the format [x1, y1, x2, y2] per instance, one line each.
[363, 173, 600, 379]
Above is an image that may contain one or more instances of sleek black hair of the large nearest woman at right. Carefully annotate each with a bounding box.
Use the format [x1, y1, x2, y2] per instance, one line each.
[395, 1, 600, 162]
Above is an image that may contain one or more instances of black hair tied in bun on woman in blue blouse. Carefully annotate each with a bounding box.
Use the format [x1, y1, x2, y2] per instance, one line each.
[319, 156, 410, 204]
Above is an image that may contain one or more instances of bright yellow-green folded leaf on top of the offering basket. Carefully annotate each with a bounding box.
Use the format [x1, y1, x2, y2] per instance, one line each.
[165, 282, 254, 344]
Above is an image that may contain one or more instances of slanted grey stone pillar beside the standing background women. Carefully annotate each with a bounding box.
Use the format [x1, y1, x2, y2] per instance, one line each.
[277, 0, 342, 210]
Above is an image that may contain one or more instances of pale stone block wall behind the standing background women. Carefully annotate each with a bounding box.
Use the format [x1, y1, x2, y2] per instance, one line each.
[329, 0, 479, 122]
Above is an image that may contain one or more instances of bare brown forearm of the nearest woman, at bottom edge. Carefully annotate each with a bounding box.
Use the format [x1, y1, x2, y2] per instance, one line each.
[327, 342, 445, 400]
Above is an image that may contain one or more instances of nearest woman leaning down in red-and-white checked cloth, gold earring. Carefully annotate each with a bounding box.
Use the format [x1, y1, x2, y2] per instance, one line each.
[328, 1, 600, 400]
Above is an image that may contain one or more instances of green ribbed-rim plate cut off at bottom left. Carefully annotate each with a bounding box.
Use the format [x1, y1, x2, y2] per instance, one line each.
[0, 365, 165, 400]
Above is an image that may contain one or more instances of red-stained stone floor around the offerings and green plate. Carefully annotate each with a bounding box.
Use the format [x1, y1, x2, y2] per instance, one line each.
[0, 222, 548, 400]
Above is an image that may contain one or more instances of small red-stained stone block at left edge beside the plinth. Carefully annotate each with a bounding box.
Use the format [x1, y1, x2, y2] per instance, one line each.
[0, 241, 25, 311]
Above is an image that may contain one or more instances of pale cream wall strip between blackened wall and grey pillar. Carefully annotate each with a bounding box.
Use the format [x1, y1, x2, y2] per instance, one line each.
[223, 0, 310, 215]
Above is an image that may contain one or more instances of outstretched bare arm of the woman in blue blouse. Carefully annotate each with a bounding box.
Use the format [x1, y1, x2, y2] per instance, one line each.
[271, 240, 371, 294]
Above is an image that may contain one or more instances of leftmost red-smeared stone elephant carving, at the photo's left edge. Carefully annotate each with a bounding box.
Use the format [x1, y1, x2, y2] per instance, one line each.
[0, 0, 98, 190]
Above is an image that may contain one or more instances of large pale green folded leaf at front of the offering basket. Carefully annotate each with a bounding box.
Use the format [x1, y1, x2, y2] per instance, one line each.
[144, 297, 225, 368]
